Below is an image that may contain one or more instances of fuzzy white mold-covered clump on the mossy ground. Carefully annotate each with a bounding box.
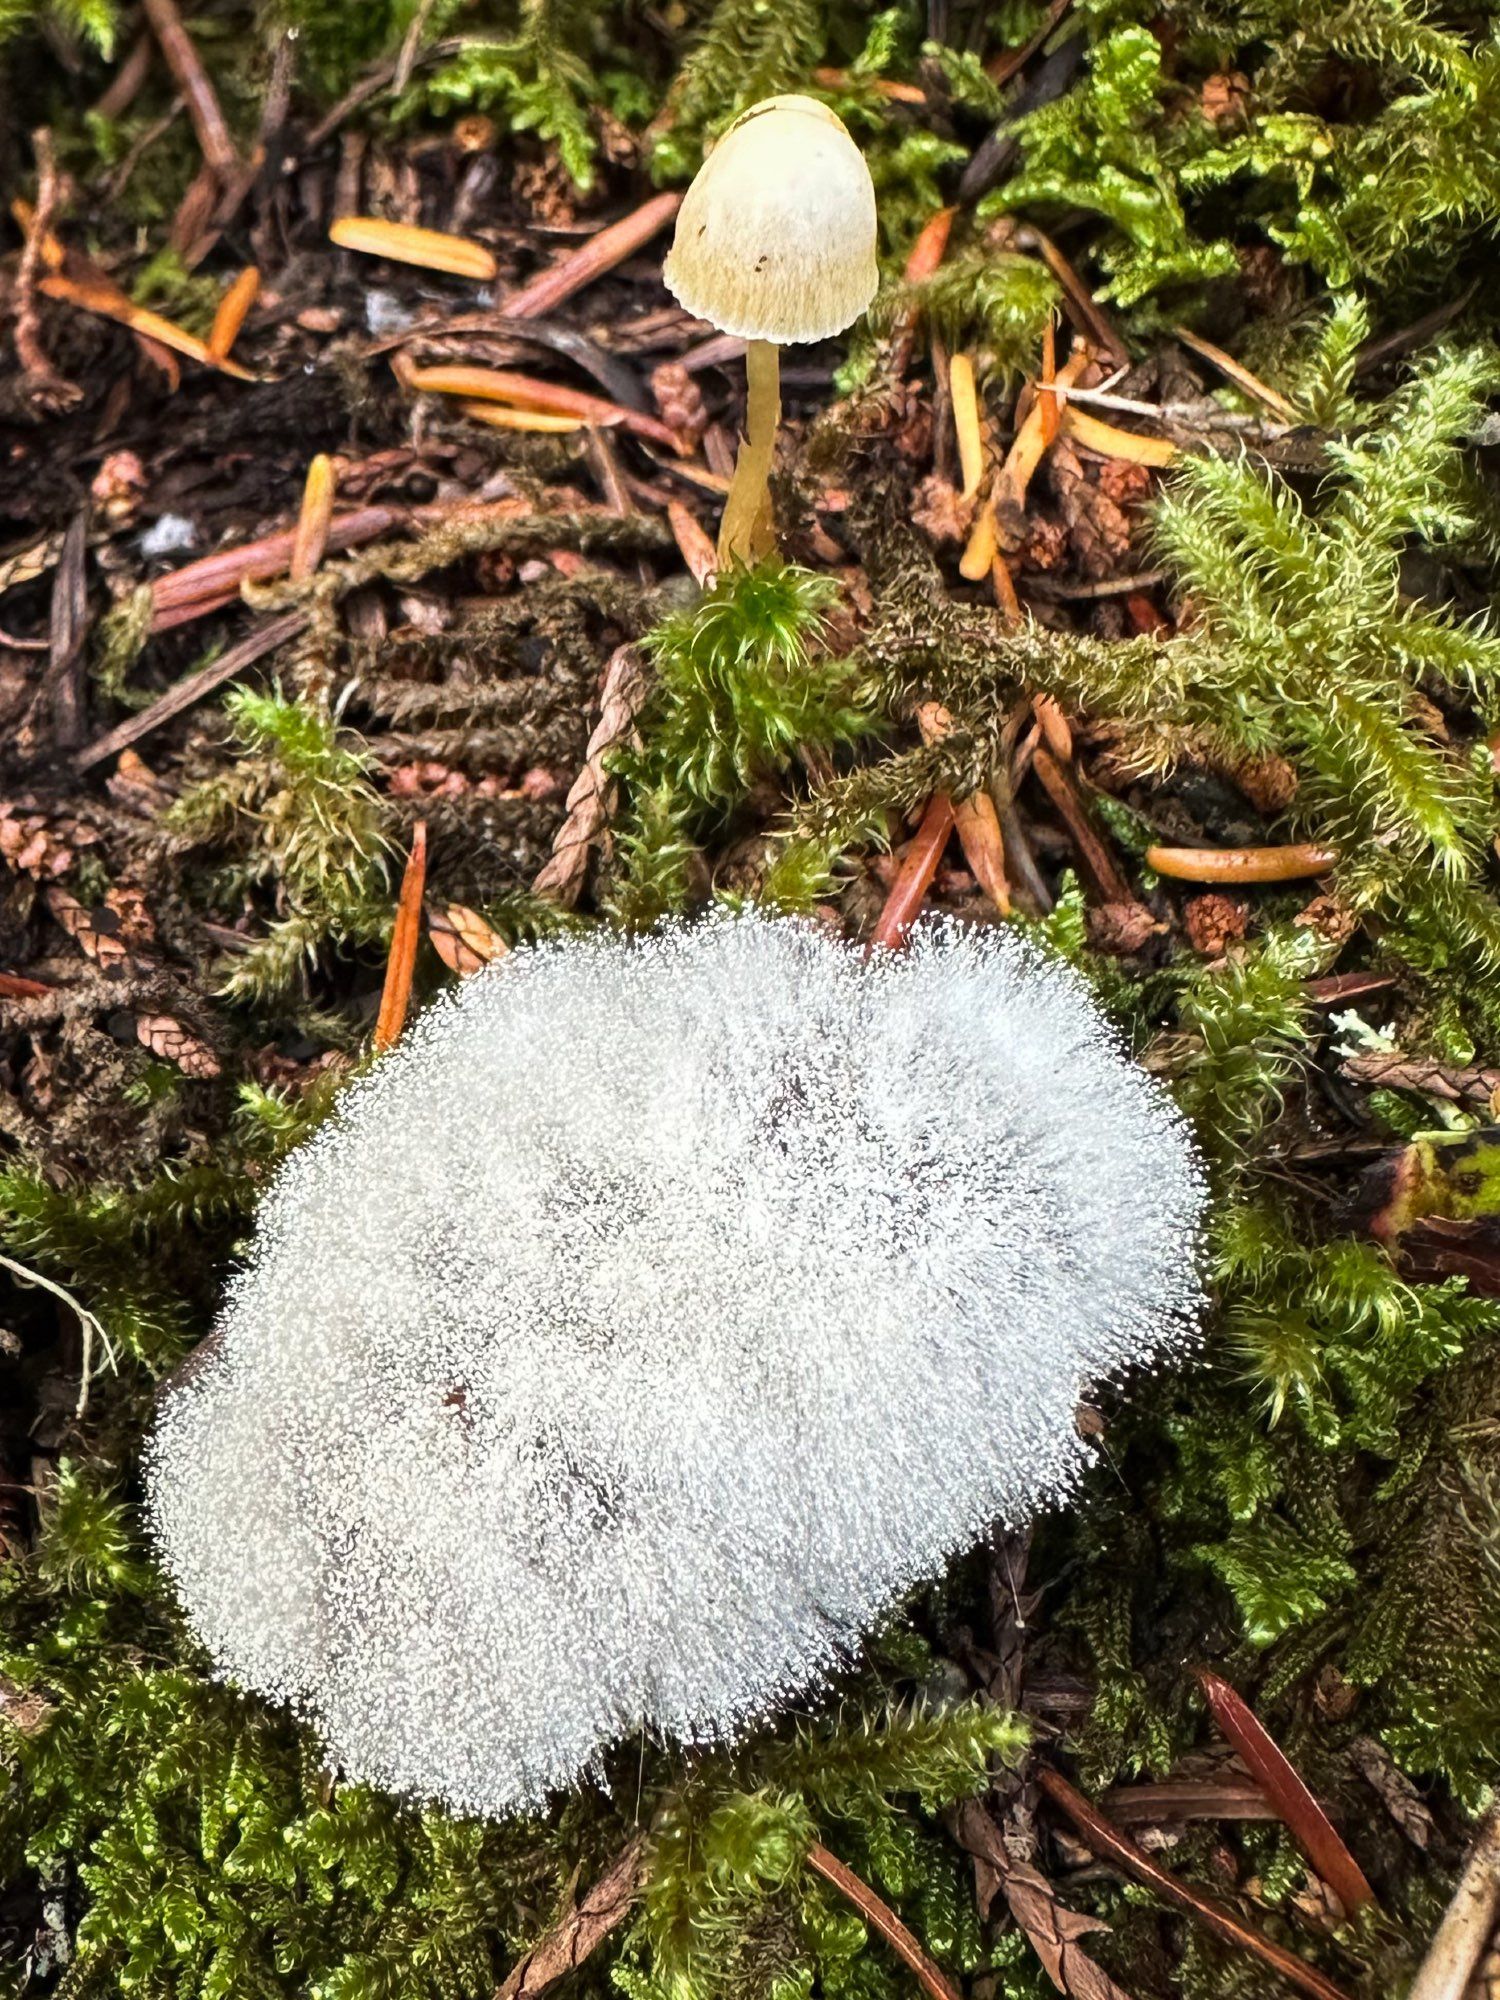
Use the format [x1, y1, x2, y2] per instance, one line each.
[148, 916, 1202, 1814]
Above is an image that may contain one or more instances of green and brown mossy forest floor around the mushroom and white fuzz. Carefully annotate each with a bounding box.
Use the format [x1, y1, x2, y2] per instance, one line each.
[0, 0, 1500, 2000]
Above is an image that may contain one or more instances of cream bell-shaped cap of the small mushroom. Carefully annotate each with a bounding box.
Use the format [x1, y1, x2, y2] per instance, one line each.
[662, 96, 878, 344]
